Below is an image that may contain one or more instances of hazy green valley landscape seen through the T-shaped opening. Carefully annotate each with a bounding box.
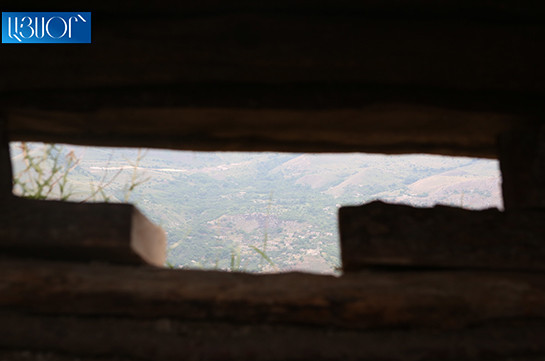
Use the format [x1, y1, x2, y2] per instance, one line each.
[11, 143, 503, 273]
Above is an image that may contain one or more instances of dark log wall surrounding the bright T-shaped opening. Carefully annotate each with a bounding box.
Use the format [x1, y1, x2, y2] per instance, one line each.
[0, 0, 545, 361]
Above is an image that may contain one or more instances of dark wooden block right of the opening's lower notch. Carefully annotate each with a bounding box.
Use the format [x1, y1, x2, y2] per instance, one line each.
[339, 201, 545, 272]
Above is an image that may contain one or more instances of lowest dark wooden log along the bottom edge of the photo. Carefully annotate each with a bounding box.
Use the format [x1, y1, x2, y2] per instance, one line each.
[0, 313, 545, 361]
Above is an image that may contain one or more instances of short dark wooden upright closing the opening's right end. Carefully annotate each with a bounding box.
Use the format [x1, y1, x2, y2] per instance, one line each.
[499, 127, 545, 209]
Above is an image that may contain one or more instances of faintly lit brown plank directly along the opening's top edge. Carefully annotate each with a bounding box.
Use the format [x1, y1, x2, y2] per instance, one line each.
[4, 104, 532, 158]
